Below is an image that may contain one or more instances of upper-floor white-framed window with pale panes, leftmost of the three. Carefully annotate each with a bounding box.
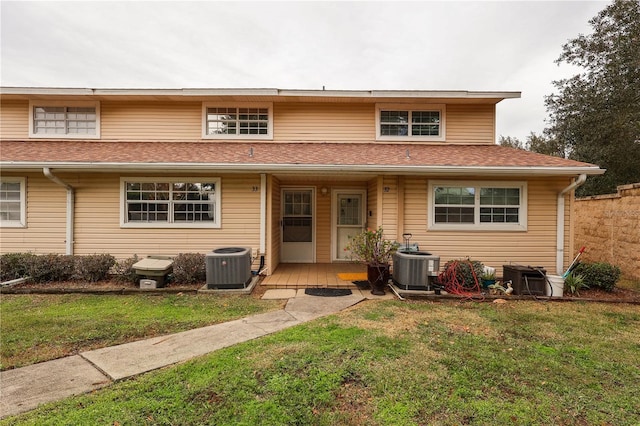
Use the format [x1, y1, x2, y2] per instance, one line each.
[29, 101, 100, 139]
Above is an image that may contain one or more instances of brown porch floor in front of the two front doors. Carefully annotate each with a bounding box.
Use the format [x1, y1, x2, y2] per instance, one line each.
[260, 263, 367, 289]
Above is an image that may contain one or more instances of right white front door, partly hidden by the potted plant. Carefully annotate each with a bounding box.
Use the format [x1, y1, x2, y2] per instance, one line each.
[333, 189, 366, 260]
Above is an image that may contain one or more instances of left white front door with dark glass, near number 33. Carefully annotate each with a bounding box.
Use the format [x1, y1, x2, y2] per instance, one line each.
[280, 188, 315, 263]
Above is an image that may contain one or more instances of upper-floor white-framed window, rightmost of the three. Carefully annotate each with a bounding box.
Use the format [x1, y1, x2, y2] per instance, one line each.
[376, 104, 445, 141]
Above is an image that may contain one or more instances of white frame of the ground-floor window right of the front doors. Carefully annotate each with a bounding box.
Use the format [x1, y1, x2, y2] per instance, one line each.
[428, 180, 528, 232]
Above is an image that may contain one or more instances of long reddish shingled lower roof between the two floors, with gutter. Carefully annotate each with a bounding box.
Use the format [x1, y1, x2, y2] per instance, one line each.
[0, 140, 604, 175]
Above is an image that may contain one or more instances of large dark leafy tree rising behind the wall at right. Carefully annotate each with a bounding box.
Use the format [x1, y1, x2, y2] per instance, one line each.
[536, 0, 640, 195]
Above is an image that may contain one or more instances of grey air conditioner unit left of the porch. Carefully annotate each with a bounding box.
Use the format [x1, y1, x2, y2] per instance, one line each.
[205, 247, 251, 289]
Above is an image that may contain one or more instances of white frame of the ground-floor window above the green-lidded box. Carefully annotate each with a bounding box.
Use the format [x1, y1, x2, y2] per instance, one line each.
[120, 176, 222, 228]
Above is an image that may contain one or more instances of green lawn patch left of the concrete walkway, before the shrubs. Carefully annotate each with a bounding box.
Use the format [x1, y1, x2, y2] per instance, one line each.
[0, 294, 280, 369]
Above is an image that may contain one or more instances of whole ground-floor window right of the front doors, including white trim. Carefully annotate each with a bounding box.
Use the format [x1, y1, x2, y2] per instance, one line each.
[429, 181, 527, 231]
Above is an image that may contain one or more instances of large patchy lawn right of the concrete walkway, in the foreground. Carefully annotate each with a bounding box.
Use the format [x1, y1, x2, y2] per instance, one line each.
[0, 301, 640, 425]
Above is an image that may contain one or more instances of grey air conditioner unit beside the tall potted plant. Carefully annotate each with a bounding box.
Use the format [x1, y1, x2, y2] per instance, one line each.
[393, 250, 440, 290]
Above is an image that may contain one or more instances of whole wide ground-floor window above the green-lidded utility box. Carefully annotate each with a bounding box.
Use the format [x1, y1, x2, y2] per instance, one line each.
[121, 178, 220, 228]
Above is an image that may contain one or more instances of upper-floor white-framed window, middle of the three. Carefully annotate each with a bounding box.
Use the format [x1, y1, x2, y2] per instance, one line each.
[203, 104, 273, 139]
